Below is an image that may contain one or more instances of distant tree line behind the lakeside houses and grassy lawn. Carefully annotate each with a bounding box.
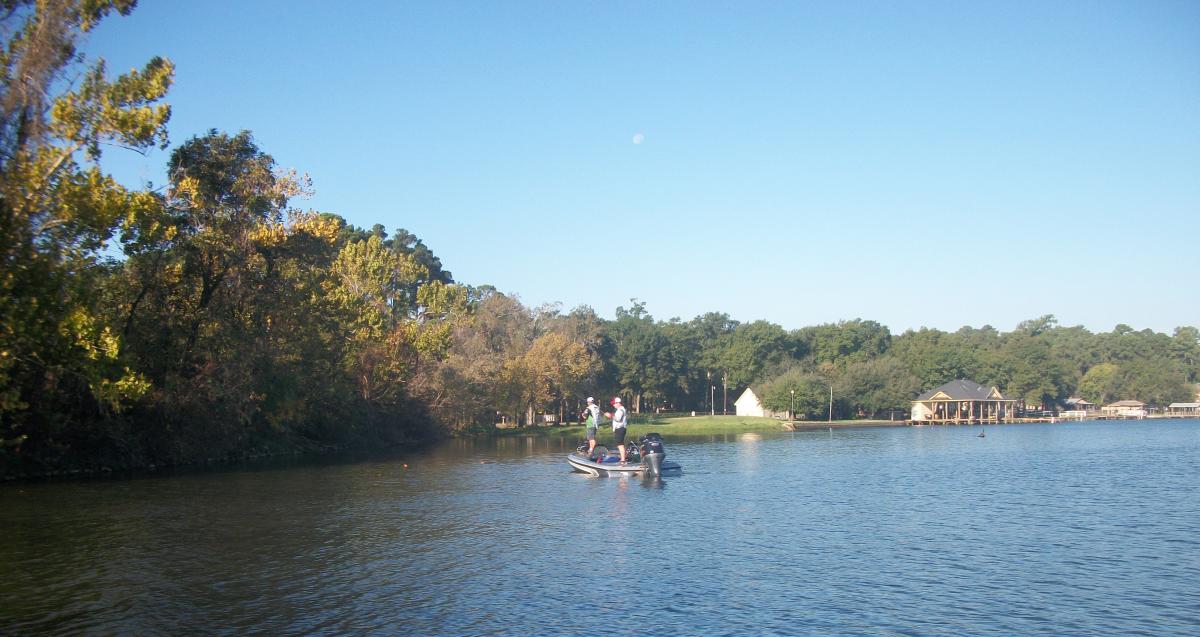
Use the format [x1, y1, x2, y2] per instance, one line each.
[431, 302, 1200, 426]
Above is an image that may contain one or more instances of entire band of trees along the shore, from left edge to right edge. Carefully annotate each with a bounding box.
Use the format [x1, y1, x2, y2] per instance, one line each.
[0, 0, 1200, 475]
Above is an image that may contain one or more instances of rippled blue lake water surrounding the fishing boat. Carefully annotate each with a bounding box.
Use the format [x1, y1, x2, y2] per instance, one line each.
[0, 420, 1200, 637]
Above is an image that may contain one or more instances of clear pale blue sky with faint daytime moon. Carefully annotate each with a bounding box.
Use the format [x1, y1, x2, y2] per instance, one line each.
[89, 0, 1200, 333]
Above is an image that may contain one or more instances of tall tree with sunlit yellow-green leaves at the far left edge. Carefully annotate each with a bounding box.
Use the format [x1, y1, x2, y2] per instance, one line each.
[0, 0, 173, 470]
